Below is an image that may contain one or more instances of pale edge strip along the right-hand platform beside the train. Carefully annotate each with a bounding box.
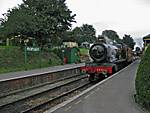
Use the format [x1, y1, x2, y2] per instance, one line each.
[44, 61, 137, 113]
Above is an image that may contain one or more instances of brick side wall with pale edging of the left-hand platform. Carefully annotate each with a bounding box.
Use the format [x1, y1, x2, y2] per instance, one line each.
[0, 65, 82, 97]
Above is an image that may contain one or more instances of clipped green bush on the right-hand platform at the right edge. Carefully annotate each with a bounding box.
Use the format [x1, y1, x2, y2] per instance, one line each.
[135, 46, 150, 108]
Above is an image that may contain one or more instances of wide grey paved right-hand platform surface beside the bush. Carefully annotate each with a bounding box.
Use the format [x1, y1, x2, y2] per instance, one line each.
[45, 61, 145, 113]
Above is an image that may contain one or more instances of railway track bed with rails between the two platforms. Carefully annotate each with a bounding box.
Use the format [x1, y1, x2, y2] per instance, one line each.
[0, 75, 90, 113]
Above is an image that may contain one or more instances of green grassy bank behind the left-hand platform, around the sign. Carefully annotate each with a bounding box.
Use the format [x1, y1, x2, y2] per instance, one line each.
[0, 46, 61, 73]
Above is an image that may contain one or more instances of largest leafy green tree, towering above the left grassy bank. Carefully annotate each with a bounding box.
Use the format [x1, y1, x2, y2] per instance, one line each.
[2, 0, 75, 45]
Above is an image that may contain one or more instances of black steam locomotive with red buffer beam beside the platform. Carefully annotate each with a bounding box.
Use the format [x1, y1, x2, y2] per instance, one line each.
[81, 37, 133, 81]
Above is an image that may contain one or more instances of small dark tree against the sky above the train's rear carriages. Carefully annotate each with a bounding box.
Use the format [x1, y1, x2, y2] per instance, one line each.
[122, 34, 135, 49]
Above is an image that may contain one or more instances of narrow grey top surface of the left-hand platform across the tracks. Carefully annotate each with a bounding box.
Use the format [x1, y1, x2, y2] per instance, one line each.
[0, 63, 85, 82]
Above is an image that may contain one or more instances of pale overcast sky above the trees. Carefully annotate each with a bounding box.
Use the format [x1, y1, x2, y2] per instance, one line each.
[0, 0, 150, 45]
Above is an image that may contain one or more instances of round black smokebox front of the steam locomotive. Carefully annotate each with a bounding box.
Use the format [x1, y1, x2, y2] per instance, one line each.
[89, 44, 107, 62]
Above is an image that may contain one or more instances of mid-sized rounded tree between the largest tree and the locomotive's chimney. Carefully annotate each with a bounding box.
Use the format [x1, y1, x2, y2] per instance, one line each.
[72, 24, 96, 45]
